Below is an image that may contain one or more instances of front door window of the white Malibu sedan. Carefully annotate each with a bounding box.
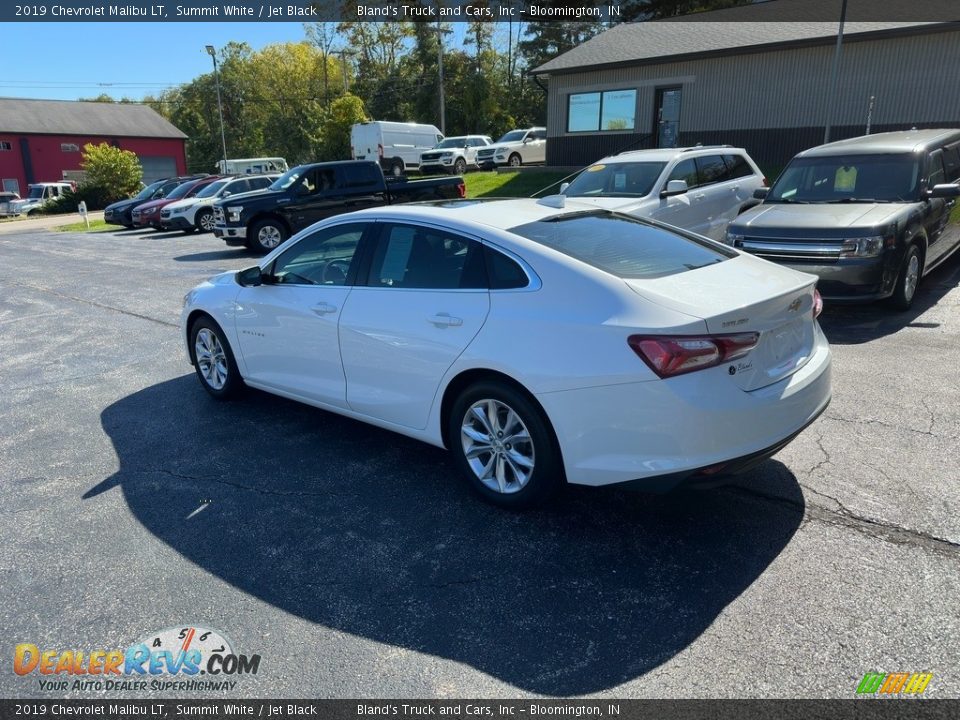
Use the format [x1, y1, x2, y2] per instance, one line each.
[270, 223, 368, 285]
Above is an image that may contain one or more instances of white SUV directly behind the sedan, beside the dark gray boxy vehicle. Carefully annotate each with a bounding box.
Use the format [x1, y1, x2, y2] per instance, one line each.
[560, 145, 767, 241]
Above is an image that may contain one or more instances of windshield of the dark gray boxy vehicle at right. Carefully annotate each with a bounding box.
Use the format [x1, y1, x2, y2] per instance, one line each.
[765, 153, 921, 204]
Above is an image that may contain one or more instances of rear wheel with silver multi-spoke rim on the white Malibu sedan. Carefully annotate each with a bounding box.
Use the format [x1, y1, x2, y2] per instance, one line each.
[447, 380, 565, 510]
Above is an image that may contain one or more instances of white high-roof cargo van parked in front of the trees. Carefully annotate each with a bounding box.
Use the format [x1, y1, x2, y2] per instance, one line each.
[350, 120, 443, 176]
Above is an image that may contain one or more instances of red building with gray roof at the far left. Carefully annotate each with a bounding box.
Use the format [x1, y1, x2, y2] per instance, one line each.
[0, 98, 187, 196]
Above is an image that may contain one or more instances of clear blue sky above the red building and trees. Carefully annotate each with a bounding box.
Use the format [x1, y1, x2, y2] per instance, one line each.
[0, 22, 462, 100]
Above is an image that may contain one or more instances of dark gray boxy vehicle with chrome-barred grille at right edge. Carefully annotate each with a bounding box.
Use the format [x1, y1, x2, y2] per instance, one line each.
[726, 130, 960, 310]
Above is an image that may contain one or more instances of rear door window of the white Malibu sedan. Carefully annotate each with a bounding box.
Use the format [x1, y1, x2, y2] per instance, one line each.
[367, 224, 488, 290]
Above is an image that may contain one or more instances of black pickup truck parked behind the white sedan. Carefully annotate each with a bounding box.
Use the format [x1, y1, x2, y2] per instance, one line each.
[213, 160, 466, 252]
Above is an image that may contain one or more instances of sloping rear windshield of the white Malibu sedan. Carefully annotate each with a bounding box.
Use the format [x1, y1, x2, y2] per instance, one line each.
[510, 211, 736, 280]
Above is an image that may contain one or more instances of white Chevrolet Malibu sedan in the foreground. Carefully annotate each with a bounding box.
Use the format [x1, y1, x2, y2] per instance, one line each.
[182, 196, 831, 507]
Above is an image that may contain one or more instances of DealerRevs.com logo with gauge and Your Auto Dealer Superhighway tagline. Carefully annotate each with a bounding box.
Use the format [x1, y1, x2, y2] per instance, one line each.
[13, 626, 260, 691]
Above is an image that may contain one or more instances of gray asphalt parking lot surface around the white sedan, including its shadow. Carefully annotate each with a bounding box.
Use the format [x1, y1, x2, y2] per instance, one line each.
[0, 225, 960, 698]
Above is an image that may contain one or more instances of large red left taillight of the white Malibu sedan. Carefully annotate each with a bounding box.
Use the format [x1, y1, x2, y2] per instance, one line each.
[627, 332, 760, 377]
